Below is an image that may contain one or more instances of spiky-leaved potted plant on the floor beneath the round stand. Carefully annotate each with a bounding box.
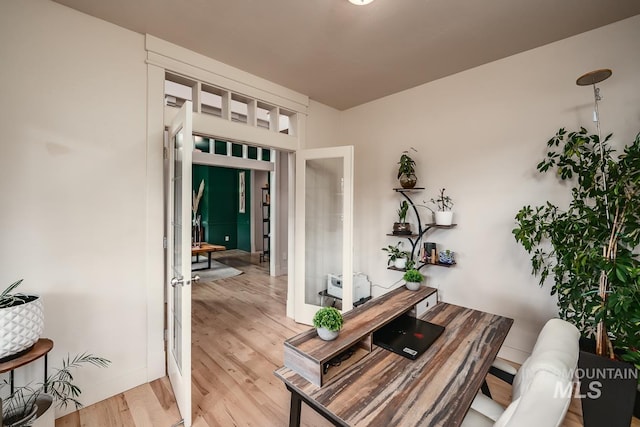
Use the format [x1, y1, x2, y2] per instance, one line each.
[0, 353, 111, 427]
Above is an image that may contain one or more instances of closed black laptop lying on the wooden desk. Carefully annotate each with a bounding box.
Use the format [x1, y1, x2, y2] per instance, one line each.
[373, 314, 444, 360]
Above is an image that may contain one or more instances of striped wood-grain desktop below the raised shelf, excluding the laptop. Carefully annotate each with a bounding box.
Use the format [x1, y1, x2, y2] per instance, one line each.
[275, 303, 513, 427]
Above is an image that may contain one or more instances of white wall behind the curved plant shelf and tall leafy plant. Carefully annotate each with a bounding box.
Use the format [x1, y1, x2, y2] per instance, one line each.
[334, 16, 640, 361]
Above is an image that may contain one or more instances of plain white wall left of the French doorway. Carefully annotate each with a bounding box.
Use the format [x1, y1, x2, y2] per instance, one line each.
[0, 0, 153, 416]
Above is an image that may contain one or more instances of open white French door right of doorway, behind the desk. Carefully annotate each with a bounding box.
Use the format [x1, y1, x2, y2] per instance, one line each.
[294, 146, 353, 325]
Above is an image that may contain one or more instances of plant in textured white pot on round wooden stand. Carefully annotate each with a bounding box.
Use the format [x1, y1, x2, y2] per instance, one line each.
[0, 279, 44, 362]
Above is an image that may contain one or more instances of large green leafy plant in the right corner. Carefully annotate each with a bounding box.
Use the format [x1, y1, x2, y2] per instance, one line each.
[513, 128, 640, 367]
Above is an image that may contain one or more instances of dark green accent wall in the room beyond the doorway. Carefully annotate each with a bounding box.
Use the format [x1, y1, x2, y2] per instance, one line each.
[193, 165, 251, 252]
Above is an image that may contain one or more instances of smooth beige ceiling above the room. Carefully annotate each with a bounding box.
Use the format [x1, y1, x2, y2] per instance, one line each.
[55, 0, 640, 110]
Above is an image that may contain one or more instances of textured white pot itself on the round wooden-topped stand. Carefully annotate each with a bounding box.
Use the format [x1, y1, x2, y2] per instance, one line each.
[0, 297, 44, 359]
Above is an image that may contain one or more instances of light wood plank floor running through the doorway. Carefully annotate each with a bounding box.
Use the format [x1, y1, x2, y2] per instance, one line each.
[56, 251, 640, 427]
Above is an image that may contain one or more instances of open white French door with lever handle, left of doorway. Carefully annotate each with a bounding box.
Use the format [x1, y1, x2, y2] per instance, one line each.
[167, 101, 193, 427]
